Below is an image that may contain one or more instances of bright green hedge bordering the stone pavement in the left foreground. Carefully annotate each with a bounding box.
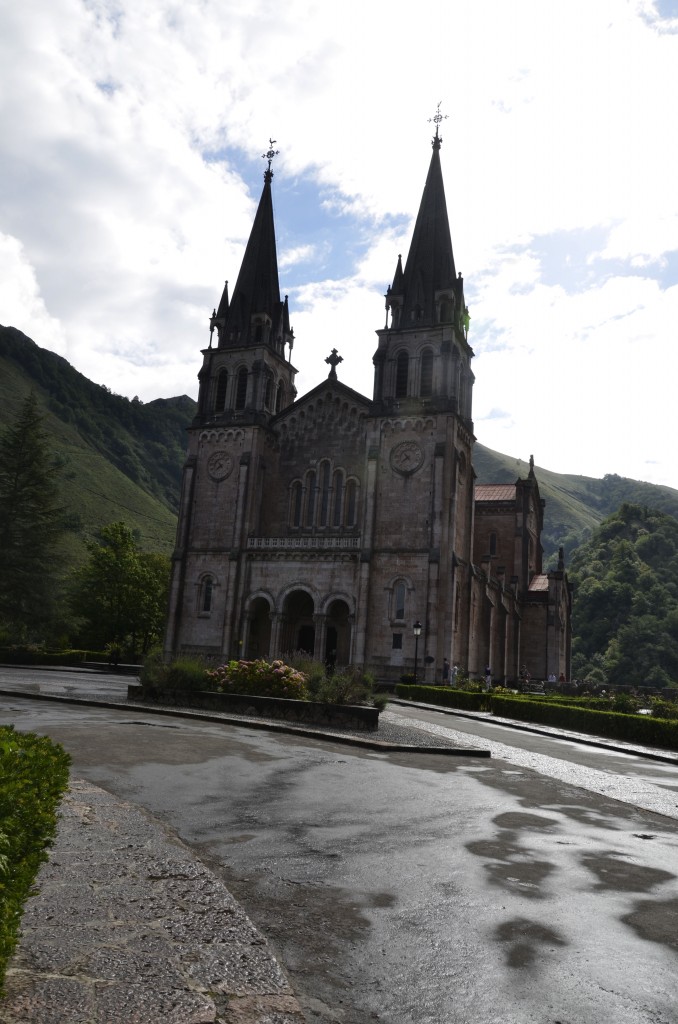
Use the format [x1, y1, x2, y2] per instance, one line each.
[0, 726, 70, 993]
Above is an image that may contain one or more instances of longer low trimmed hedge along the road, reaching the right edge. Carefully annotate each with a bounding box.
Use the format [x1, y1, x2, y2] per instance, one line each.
[492, 696, 678, 751]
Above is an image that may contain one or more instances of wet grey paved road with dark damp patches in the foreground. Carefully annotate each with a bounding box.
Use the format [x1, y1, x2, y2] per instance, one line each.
[0, 682, 678, 1024]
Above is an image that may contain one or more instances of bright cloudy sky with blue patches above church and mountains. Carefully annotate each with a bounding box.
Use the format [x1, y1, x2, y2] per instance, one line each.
[0, 0, 678, 487]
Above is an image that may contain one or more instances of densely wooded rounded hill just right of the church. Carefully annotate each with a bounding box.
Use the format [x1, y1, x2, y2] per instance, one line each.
[569, 504, 678, 688]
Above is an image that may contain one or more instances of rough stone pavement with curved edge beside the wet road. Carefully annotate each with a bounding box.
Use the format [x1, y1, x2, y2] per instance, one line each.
[0, 780, 304, 1024]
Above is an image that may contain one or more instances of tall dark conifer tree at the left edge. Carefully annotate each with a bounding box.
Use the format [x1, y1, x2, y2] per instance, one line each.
[0, 392, 66, 640]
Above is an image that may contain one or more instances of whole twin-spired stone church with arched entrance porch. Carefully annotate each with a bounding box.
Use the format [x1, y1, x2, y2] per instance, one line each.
[165, 129, 571, 682]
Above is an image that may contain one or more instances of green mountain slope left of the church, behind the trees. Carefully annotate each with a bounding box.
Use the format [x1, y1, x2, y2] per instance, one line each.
[0, 327, 196, 559]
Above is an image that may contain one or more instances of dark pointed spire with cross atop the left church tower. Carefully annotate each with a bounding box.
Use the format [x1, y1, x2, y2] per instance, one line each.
[214, 139, 290, 348]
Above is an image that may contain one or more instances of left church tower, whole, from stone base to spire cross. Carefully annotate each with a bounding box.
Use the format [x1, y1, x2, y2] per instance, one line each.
[166, 139, 296, 659]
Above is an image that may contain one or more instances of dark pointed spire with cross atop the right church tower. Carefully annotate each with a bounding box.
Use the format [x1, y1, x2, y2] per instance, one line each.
[390, 103, 459, 328]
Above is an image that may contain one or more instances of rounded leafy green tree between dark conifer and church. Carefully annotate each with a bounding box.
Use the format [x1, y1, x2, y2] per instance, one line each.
[72, 522, 169, 653]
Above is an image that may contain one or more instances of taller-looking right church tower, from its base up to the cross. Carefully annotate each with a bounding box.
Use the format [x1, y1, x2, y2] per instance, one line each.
[356, 108, 474, 674]
